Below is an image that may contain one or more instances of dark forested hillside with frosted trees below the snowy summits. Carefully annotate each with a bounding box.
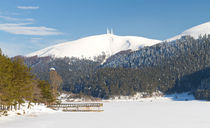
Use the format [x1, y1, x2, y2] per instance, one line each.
[25, 36, 210, 100]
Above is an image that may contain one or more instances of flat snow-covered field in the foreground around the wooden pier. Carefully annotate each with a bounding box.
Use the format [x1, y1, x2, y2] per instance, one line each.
[0, 93, 210, 128]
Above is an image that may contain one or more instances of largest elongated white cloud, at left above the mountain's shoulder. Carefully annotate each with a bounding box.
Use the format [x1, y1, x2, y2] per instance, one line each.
[0, 23, 62, 36]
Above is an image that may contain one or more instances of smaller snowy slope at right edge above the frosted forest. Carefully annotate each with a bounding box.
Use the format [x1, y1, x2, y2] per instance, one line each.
[166, 22, 210, 41]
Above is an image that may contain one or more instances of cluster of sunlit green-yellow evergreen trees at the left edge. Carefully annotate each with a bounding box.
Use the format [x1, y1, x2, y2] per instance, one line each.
[0, 50, 55, 110]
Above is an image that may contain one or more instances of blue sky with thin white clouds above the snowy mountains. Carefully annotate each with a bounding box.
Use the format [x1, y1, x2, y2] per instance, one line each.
[0, 0, 210, 56]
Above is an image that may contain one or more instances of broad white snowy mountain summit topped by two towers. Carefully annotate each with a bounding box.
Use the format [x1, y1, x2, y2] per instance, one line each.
[26, 34, 160, 59]
